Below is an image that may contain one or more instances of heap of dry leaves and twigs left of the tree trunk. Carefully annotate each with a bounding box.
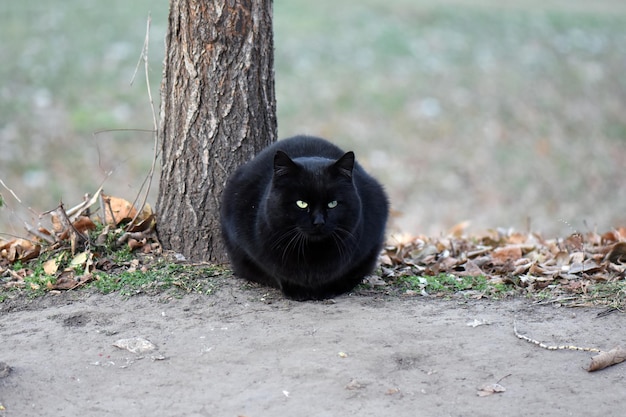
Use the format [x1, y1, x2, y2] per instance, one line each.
[0, 188, 162, 291]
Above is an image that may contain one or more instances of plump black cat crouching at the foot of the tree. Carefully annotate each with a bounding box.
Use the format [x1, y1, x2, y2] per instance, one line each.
[221, 136, 389, 300]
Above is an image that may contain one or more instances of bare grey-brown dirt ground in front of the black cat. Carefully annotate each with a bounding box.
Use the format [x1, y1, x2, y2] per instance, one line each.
[0, 281, 626, 417]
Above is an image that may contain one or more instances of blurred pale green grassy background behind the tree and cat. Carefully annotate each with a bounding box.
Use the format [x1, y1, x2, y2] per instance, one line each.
[0, 0, 626, 237]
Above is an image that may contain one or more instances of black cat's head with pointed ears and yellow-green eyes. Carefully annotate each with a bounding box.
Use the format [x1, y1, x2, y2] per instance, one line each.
[265, 151, 361, 242]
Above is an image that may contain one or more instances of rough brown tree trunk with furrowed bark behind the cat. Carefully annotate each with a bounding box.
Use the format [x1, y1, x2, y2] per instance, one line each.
[157, 0, 276, 263]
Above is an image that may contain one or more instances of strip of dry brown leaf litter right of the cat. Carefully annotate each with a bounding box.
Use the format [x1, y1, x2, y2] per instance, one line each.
[381, 227, 626, 309]
